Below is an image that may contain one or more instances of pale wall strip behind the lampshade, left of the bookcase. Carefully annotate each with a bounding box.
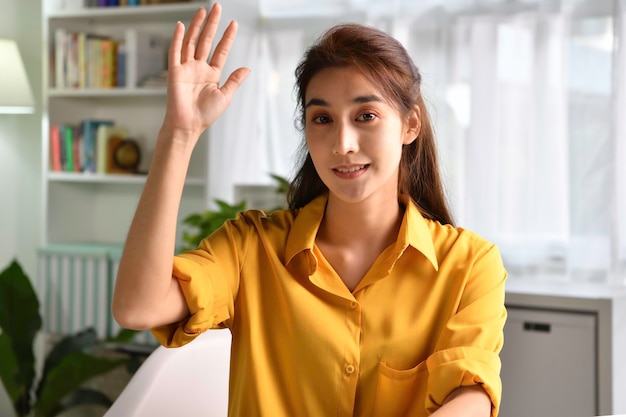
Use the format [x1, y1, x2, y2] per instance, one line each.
[0, 0, 42, 278]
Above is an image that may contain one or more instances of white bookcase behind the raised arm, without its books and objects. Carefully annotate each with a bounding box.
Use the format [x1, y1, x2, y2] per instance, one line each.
[42, 0, 210, 247]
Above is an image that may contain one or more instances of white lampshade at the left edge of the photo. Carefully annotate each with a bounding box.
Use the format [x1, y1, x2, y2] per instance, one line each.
[0, 39, 35, 113]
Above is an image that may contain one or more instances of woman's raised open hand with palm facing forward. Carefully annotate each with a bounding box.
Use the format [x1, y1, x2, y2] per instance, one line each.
[163, 3, 250, 139]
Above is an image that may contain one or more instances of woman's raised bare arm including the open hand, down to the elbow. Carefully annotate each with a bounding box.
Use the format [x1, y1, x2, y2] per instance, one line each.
[112, 3, 249, 329]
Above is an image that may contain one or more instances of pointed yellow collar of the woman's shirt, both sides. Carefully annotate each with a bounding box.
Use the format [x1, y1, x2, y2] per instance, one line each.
[285, 194, 439, 271]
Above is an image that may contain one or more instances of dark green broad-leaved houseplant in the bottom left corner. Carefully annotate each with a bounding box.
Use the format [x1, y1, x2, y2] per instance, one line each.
[0, 261, 129, 417]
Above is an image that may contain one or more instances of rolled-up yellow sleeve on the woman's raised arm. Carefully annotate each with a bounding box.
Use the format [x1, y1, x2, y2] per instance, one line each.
[151, 216, 249, 347]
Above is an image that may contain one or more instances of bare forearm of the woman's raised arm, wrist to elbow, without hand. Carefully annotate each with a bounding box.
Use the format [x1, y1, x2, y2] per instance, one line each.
[112, 129, 195, 329]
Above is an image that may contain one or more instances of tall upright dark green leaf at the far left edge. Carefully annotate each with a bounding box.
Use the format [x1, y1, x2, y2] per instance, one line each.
[0, 261, 41, 414]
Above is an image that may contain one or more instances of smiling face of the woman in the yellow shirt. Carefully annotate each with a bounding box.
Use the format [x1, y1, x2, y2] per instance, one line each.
[304, 67, 419, 203]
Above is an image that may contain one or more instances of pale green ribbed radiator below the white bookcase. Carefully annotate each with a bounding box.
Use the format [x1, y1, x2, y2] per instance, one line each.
[36, 244, 157, 345]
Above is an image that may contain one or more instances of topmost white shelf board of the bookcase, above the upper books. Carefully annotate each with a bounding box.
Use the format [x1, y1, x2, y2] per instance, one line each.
[48, 1, 209, 23]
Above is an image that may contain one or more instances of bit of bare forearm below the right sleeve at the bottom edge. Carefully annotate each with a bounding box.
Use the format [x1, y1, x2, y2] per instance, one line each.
[431, 385, 491, 417]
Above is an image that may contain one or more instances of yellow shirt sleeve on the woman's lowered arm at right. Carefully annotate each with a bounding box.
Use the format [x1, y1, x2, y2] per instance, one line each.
[426, 242, 506, 417]
